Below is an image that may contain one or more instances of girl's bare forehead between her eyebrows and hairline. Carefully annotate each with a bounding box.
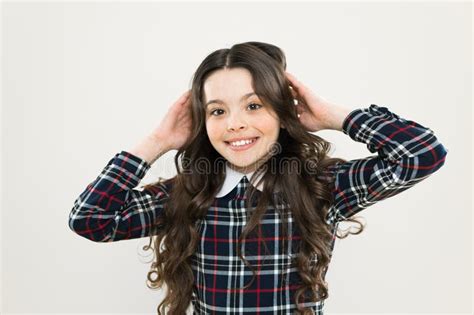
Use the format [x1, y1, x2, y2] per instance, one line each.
[203, 68, 254, 101]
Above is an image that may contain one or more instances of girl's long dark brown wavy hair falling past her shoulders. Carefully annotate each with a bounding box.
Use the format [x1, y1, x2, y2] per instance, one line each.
[139, 42, 364, 315]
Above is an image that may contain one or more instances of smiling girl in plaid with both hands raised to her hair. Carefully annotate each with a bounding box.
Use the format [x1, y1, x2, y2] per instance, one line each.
[69, 42, 447, 314]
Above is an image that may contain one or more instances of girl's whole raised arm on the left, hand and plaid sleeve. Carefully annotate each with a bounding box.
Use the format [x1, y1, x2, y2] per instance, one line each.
[69, 90, 191, 242]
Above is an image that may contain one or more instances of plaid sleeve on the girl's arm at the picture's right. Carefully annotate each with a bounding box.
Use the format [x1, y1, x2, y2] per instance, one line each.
[326, 104, 448, 224]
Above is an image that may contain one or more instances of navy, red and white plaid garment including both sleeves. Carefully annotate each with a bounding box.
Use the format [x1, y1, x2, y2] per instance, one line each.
[69, 104, 447, 314]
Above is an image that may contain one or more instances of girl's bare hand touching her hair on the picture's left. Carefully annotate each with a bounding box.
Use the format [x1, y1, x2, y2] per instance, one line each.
[151, 90, 191, 150]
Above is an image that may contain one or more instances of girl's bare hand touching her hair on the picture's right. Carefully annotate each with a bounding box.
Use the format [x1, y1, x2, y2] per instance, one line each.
[285, 71, 333, 132]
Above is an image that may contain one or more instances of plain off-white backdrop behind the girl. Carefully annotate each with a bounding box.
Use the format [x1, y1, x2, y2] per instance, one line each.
[0, 1, 472, 314]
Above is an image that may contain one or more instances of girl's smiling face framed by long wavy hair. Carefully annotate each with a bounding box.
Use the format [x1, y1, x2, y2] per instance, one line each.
[204, 68, 280, 174]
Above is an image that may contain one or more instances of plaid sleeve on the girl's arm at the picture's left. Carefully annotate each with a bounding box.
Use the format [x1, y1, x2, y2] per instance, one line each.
[69, 151, 169, 242]
